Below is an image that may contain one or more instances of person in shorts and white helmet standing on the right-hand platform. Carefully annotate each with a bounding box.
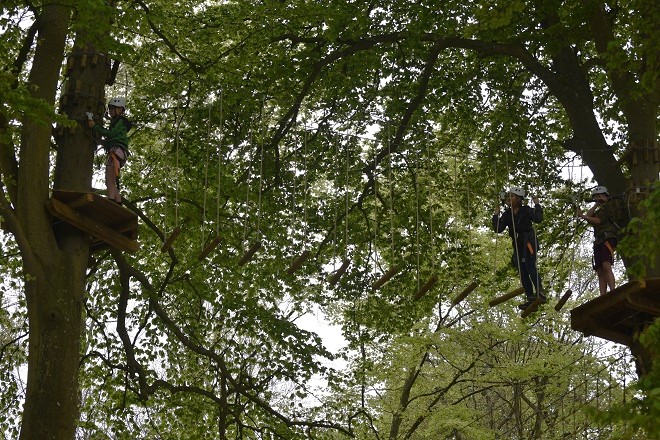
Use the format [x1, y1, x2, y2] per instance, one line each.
[576, 186, 620, 295]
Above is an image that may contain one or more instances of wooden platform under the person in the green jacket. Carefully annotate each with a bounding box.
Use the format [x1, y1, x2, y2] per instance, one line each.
[47, 190, 140, 252]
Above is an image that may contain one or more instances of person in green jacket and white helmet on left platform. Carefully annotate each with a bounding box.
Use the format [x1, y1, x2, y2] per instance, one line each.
[87, 97, 133, 204]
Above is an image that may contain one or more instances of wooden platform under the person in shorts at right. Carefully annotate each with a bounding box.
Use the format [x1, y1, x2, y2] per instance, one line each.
[571, 278, 660, 347]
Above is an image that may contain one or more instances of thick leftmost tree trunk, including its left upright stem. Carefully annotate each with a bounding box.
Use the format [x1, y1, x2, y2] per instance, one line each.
[15, 2, 82, 440]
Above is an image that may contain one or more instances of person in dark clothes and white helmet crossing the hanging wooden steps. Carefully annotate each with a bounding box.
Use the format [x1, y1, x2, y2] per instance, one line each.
[493, 186, 546, 310]
